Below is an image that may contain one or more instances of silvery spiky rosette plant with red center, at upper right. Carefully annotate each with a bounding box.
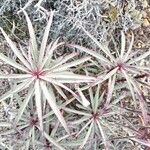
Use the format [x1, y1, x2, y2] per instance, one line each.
[70, 27, 150, 123]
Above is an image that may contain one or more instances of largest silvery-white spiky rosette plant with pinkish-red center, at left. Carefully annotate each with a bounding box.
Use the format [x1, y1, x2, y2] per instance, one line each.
[0, 10, 94, 133]
